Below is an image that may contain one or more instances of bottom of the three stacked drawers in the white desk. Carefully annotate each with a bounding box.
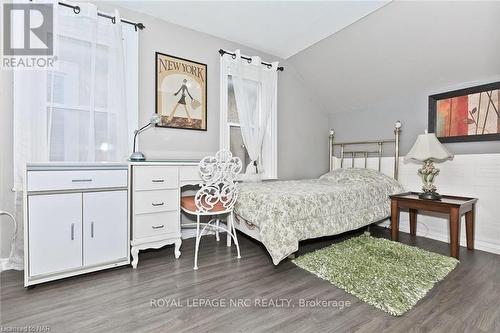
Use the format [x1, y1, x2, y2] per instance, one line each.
[134, 211, 180, 239]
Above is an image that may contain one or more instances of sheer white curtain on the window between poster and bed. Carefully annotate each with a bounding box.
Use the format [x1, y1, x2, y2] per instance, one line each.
[228, 50, 278, 175]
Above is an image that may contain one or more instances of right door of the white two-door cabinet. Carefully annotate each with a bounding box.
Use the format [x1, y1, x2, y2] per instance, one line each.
[83, 191, 128, 266]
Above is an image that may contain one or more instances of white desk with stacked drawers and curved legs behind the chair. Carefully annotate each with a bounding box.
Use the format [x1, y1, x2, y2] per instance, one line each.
[129, 161, 201, 268]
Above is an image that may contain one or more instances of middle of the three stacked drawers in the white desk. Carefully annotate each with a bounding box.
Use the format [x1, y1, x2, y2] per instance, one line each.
[134, 190, 180, 214]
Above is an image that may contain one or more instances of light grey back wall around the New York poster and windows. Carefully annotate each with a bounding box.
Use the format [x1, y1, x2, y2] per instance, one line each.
[0, 2, 328, 257]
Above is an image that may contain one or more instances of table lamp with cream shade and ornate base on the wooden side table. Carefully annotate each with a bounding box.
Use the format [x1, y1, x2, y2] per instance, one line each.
[405, 131, 453, 200]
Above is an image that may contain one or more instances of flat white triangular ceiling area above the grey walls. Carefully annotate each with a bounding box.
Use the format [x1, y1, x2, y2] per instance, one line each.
[120, 0, 390, 59]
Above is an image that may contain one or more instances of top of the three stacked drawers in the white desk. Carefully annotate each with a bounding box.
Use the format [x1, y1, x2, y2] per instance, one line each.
[134, 165, 179, 191]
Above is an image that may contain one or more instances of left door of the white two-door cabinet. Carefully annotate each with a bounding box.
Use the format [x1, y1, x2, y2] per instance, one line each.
[28, 193, 82, 276]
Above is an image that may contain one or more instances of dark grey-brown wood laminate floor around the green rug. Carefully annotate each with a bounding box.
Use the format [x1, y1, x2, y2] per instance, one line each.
[0, 228, 500, 332]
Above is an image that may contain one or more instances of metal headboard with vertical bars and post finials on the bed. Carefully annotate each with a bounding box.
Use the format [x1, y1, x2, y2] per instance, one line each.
[329, 120, 401, 180]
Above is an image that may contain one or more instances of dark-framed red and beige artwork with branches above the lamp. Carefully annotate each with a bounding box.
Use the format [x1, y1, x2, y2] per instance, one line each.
[429, 82, 500, 142]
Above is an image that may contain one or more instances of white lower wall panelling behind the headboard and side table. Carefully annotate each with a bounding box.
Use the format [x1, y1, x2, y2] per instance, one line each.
[334, 154, 500, 254]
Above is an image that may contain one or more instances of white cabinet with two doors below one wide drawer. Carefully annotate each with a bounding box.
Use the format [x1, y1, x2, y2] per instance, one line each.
[24, 163, 130, 286]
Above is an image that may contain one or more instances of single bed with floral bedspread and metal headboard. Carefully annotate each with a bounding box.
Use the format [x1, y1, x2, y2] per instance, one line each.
[235, 122, 404, 265]
